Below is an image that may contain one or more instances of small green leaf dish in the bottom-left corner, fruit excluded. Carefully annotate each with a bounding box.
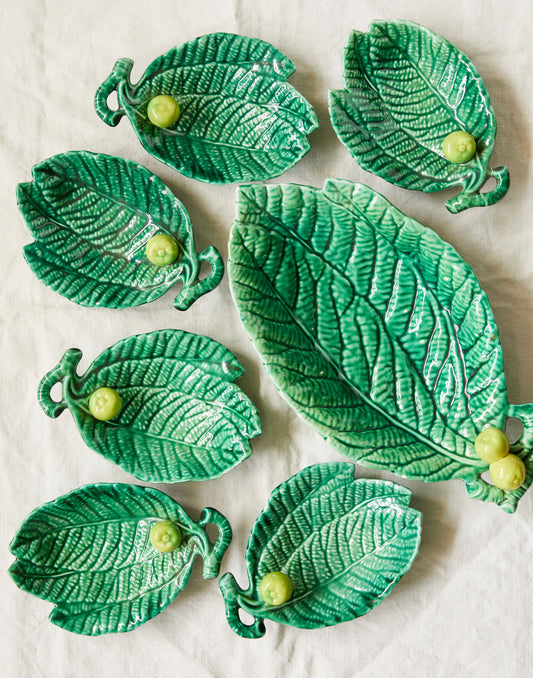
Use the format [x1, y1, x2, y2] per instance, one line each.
[9, 484, 231, 636]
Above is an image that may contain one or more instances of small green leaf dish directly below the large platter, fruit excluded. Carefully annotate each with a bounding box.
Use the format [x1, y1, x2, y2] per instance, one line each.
[220, 463, 421, 638]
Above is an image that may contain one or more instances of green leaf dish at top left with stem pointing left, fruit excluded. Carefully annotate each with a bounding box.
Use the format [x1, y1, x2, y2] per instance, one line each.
[95, 33, 318, 184]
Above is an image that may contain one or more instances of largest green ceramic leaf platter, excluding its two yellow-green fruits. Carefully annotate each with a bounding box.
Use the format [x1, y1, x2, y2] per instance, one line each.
[229, 179, 533, 512]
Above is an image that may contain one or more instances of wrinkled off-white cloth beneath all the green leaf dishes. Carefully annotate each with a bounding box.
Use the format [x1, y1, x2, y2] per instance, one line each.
[0, 0, 533, 678]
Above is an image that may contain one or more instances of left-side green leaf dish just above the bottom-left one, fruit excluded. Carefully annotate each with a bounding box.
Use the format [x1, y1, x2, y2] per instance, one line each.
[38, 330, 261, 483]
